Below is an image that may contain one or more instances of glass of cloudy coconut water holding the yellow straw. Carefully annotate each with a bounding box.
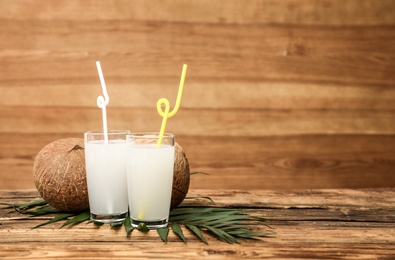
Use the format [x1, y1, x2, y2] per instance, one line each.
[127, 132, 174, 229]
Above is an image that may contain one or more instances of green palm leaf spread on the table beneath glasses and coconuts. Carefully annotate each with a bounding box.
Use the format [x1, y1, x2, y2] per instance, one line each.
[0, 200, 275, 244]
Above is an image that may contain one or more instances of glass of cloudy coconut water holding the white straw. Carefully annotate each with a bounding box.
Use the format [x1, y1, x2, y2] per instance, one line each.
[84, 130, 130, 223]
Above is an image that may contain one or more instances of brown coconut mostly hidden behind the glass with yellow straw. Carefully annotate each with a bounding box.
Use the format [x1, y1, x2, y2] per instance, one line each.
[170, 143, 191, 209]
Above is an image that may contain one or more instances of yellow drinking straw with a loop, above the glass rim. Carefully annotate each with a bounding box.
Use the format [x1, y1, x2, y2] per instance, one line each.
[156, 64, 187, 147]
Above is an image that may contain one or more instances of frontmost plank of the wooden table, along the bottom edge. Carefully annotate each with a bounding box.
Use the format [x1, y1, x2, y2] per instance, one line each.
[0, 244, 395, 259]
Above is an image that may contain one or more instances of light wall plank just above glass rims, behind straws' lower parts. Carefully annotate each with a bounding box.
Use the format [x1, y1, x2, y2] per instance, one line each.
[0, 106, 395, 136]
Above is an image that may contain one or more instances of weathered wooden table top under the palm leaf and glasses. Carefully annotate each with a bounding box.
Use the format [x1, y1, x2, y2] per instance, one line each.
[0, 188, 395, 259]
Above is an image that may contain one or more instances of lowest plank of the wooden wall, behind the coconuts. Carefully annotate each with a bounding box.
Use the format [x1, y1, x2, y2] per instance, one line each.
[0, 133, 395, 190]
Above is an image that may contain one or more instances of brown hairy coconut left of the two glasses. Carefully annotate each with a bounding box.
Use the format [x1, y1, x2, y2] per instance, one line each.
[33, 138, 89, 212]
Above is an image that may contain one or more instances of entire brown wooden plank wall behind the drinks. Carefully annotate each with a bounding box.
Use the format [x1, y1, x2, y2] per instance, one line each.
[0, 0, 395, 189]
